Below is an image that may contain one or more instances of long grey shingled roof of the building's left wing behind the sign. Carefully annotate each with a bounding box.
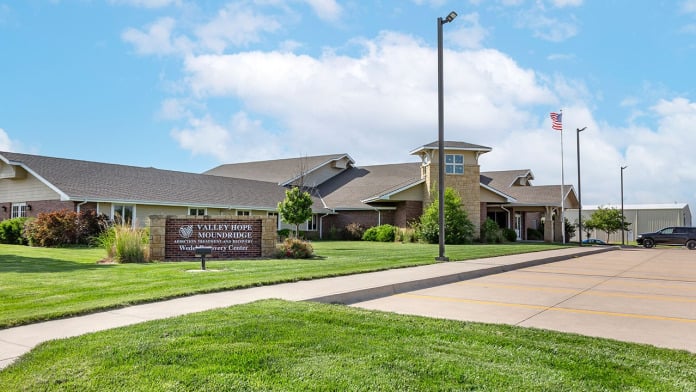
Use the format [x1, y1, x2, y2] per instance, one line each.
[0, 152, 321, 209]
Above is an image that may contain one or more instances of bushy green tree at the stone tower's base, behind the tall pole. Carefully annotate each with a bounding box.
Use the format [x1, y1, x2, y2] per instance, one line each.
[419, 188, 474, 244]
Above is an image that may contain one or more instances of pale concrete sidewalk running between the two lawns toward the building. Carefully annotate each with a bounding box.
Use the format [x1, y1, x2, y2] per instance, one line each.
[0, 247, 617, 369]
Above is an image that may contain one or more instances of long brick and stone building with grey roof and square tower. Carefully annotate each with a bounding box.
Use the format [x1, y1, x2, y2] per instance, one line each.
[0, 142, 577, 241]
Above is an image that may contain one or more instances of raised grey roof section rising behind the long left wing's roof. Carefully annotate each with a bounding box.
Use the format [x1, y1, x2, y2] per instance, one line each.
[203, 154, 355, 185]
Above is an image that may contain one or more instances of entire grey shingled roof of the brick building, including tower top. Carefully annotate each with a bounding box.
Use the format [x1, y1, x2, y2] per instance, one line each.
[0, 142, 577, 212]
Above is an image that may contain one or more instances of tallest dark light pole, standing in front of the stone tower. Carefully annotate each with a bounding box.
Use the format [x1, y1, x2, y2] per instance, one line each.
[435, 11, 457, 261]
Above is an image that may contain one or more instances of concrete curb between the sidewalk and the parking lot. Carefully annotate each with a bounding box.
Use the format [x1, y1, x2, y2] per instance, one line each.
[304, 246, 620, 305]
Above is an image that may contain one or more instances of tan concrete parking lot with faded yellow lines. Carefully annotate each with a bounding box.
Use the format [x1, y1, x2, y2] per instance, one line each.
[352, 247, 696, 352]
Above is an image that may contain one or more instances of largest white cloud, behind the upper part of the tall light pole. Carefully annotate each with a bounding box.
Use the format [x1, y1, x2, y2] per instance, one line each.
[178, 33, 555, 164]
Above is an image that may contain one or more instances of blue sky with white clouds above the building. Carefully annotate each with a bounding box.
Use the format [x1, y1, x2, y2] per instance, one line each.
[0, 0, 696, 209]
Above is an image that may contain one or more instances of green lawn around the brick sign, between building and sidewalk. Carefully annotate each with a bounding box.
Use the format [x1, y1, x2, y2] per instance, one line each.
[0, 242, 559, 328]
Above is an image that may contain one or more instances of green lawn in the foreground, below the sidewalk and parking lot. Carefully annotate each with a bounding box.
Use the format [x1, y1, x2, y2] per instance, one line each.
[0, 300, 696, 391]
